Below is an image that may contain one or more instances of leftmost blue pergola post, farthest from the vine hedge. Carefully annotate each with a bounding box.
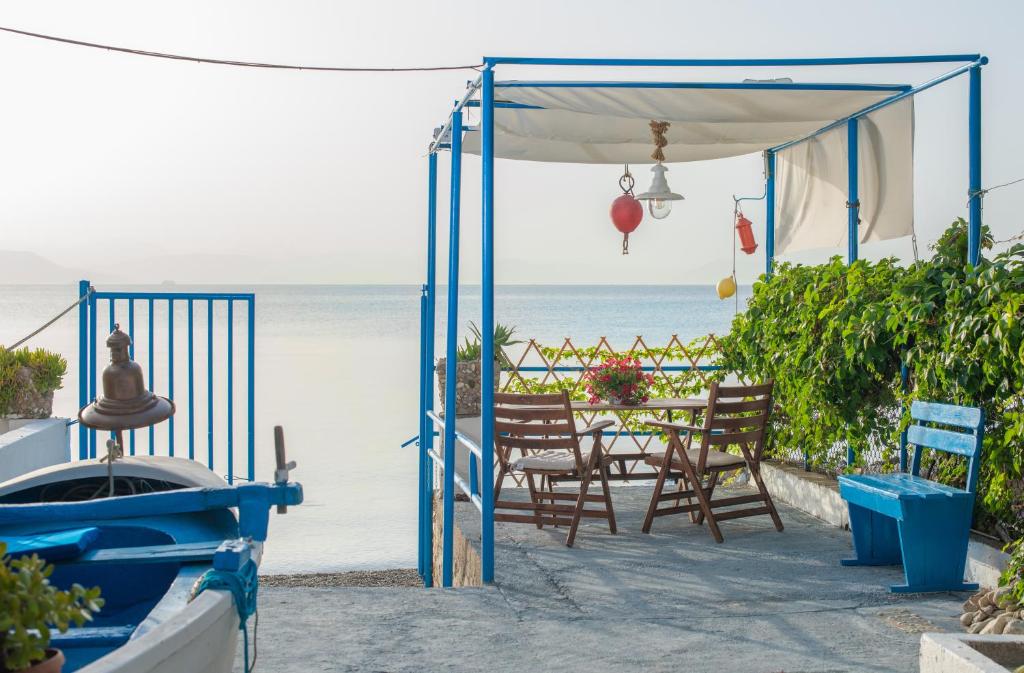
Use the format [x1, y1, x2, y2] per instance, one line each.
[419, 152, 437, 587]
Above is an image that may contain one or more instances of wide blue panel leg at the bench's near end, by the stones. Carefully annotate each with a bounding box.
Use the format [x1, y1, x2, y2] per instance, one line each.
[889, 499, 978, 593]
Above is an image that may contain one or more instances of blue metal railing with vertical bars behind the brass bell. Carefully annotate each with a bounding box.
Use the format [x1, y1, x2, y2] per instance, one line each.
[78, 281, 256, 483]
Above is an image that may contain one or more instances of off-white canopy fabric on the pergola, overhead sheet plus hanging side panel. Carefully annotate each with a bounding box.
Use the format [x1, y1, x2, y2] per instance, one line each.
[463, 82, 913, 254]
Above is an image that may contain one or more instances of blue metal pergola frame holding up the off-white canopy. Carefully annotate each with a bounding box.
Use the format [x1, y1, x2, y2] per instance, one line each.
[418, 53, 988, 587]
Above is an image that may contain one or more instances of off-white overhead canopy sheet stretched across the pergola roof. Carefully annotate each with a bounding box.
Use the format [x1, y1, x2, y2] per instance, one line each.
[463, 82, 904, 164]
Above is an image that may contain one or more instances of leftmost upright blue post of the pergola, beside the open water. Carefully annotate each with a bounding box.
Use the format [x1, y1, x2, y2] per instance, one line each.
[420, 153, 437, 587]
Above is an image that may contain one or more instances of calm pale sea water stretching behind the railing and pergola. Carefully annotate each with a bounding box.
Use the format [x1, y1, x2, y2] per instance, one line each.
[0, 285, 750, 574]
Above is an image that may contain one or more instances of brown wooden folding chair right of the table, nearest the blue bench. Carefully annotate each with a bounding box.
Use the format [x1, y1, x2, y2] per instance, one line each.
[643, 381, 782, 542]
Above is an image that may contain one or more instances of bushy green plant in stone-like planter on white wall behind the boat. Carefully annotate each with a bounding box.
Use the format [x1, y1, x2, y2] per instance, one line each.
[0, 347, 68, 418]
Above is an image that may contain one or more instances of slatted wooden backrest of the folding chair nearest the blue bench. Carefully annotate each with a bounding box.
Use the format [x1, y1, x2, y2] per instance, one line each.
[697, 381, 775, 471]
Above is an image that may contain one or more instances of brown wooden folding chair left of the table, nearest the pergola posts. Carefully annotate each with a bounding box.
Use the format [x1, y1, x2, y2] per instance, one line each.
[495, 391, 615, 547]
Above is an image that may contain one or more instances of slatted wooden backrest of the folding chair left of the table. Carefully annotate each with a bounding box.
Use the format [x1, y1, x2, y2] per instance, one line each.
[495, 391, 584, 470]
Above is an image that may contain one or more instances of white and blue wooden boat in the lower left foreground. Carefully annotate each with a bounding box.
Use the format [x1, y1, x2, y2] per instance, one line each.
[0, 456, 302, 673]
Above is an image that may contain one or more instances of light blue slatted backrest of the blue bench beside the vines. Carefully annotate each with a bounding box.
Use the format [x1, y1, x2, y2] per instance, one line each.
[906, 402, 985, 493]
